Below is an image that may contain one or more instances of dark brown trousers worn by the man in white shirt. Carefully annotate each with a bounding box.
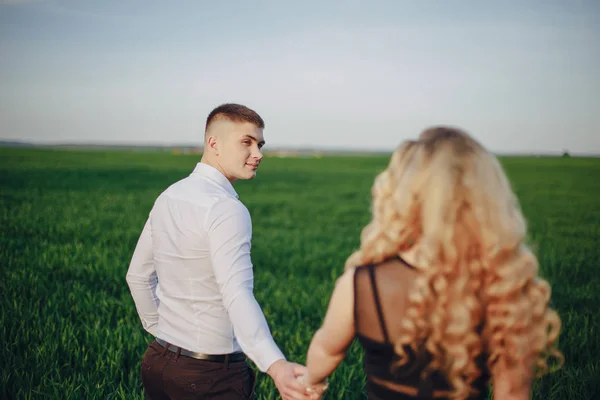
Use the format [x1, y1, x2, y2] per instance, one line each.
[141, 341, 256, 400]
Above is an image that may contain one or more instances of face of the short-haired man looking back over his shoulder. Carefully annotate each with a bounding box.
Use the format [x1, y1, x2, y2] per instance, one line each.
[218, 122, 265, 182]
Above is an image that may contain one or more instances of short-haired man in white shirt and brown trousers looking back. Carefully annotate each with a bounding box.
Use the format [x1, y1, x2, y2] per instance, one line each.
[126, 104, 324, 400]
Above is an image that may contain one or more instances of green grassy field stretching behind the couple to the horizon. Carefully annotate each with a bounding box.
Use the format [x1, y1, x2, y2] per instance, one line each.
[0, 149, 600, 399]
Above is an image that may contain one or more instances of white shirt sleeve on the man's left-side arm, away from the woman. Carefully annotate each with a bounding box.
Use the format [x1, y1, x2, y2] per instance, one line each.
[125, 218, 159, 336]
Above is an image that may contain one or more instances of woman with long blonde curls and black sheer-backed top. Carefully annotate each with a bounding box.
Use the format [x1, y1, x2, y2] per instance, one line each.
[304, 127, 563, 399]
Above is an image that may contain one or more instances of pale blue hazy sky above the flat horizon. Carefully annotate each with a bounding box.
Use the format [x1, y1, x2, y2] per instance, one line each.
[0, 0, 600, 154]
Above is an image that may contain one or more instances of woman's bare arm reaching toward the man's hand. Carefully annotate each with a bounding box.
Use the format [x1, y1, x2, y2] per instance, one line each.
[304, 269, 354, 385]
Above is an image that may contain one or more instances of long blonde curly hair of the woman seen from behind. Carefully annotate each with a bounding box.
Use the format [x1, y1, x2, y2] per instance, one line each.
[346, 127, 564, 398]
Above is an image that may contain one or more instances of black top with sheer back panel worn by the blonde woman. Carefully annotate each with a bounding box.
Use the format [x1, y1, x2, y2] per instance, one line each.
[354, 258, 489, 400]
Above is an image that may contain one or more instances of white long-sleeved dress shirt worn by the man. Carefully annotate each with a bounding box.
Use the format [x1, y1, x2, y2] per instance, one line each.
[126, 163, 285, 372]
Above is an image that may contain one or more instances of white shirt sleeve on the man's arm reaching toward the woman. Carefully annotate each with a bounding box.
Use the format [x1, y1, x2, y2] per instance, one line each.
[205, 199, 285, 372]
